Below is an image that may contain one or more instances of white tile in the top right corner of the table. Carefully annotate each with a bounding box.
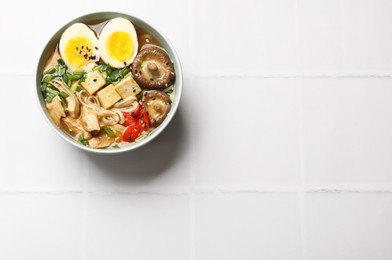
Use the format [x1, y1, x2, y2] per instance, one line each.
[299, 0, 392, 74]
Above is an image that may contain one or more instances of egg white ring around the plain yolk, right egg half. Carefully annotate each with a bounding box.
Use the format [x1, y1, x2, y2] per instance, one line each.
[98, 17, 139, 68]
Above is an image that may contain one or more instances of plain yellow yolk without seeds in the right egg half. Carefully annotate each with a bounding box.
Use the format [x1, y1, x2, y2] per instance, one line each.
[106, 32, 134, 62]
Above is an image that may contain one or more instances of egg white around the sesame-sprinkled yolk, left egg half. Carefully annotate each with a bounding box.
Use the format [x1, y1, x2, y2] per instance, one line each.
[59, 23, 99, 71]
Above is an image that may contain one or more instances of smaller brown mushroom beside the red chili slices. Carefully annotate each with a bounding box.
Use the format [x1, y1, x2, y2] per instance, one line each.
[142, 90, 171, 127]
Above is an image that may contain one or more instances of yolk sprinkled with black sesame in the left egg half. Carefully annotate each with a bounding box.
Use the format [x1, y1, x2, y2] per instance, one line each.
[65, 37, 93, 68]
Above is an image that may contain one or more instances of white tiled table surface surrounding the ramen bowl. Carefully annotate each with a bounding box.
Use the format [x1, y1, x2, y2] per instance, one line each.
[0, 0, 392, 260]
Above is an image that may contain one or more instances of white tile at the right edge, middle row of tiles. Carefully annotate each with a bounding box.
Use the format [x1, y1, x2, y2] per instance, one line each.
[302, 78, 392, 188]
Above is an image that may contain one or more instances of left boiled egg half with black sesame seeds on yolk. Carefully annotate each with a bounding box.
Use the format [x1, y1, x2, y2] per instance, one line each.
[59, 23, 99, 71]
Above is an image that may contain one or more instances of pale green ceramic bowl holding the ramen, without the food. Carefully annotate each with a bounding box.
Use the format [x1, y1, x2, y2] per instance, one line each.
[36, 12, 183, 154]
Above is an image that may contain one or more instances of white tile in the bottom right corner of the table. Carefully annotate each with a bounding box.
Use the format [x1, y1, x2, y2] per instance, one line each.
[306, 193, 392, 260]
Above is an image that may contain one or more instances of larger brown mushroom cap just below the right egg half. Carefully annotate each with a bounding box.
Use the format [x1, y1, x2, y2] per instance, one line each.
[132, 45, 175, 89]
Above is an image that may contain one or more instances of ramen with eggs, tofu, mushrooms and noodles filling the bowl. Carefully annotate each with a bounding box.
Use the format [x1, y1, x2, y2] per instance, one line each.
[41, 17, 175, 149]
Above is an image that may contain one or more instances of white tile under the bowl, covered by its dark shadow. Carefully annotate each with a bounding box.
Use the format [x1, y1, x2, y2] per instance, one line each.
[87, 76, 192, 190]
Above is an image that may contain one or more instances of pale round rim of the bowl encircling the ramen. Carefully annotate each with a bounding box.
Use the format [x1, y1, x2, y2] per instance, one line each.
[35, 11, 183, 154]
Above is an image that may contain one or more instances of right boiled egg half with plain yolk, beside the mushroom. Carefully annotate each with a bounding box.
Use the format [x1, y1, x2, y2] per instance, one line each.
[99, 17, 139, 68]
